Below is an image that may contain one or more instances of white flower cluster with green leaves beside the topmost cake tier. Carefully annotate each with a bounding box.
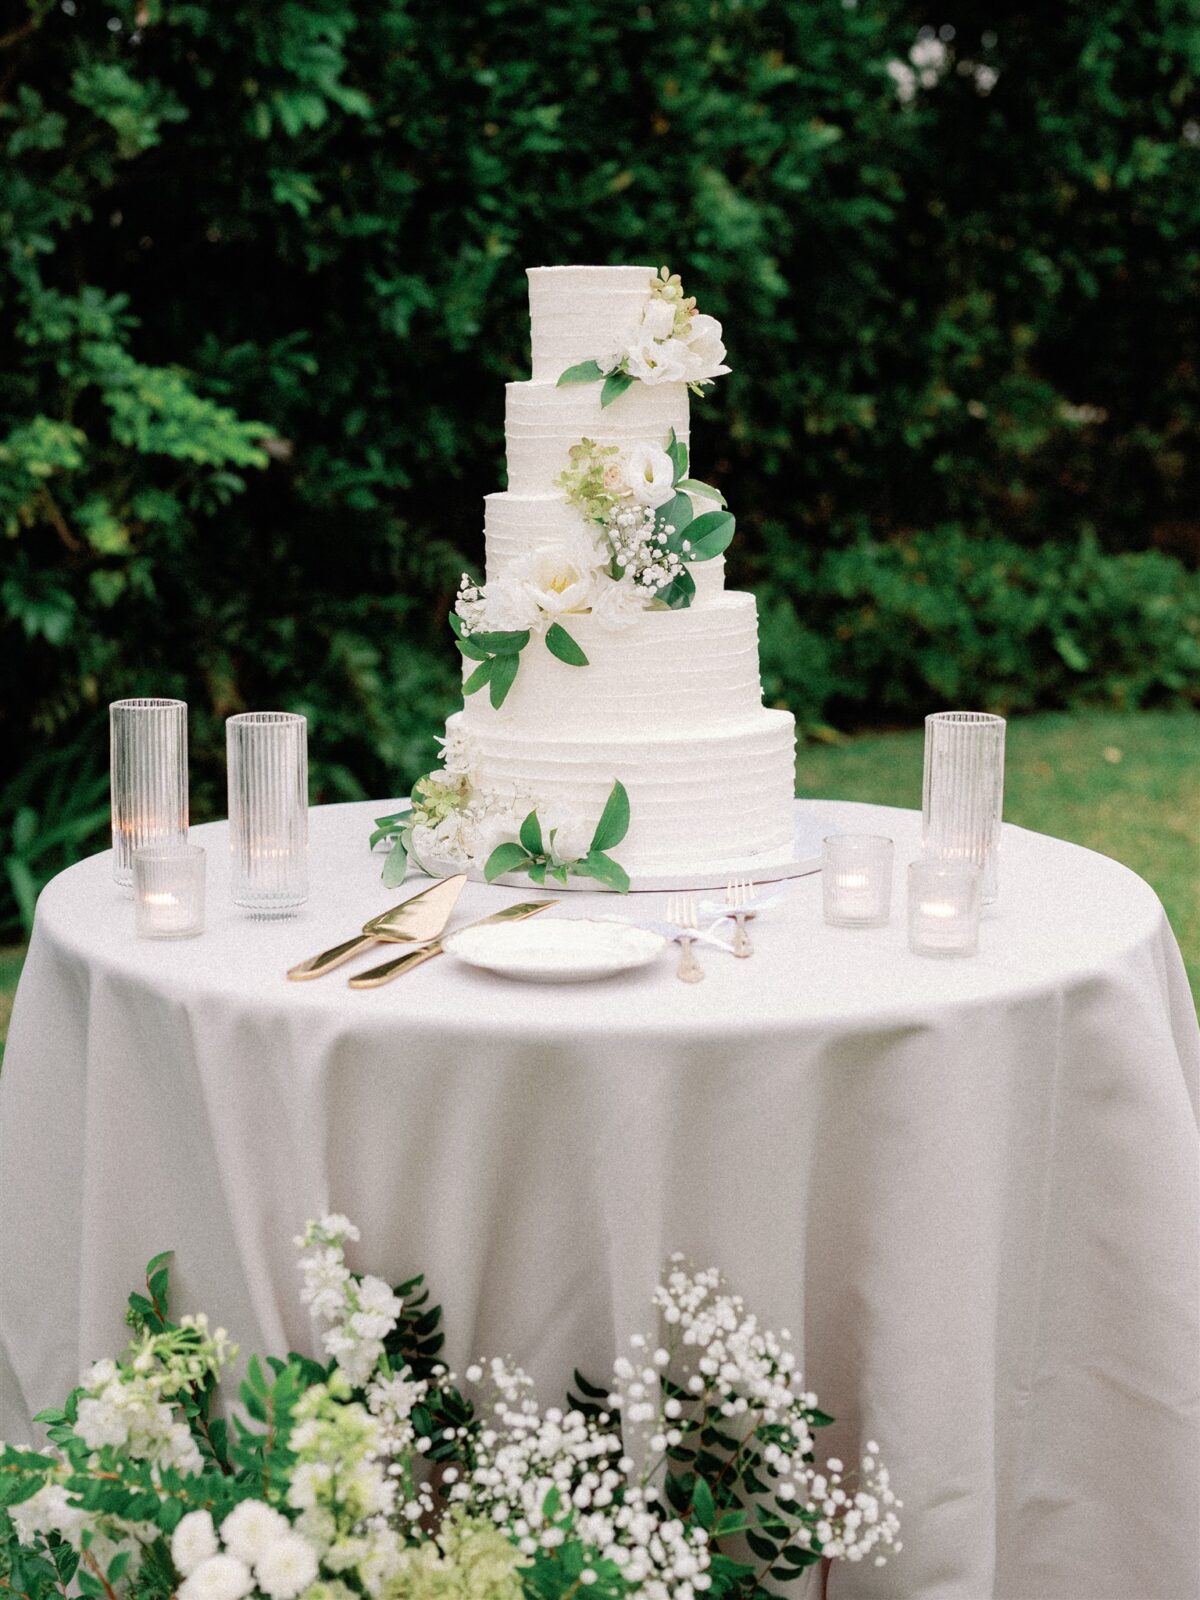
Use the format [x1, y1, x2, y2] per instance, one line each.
[558, 267, 730, 406]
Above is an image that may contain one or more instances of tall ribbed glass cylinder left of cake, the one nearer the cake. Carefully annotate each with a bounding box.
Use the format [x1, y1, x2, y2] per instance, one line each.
[226, 710, 309, 917]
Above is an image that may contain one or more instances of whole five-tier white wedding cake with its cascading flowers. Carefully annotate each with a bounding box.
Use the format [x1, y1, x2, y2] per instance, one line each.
[373, 267, 795, 890]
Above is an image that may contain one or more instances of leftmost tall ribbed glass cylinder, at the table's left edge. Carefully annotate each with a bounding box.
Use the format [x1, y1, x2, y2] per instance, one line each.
[109, 699, 187, 888]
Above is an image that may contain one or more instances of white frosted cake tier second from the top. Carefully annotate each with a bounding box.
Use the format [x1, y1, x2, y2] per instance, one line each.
[504, 382, 688, 494]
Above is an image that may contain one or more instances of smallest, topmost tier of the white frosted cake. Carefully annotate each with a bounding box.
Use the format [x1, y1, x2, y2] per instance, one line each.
[526, 267, 654, 384]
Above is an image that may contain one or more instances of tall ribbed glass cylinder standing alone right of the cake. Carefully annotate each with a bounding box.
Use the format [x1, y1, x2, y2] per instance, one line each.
[922, 710, 1006, 904]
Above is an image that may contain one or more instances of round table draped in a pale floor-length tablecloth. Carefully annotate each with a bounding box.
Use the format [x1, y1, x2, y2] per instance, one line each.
[0, 802, 1200, 1600]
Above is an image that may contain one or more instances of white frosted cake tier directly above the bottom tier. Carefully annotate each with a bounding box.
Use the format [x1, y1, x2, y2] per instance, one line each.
[462, 594, 762, 738]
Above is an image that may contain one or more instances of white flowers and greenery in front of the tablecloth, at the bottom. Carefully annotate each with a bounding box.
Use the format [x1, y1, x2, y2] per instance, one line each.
[0, 1216, 901, 1600]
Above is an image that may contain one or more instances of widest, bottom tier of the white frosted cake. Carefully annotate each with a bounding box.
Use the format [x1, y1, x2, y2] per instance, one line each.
[448, 707, 795, 877]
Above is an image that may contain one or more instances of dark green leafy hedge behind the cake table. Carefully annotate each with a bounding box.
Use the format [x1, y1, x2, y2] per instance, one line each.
[0, 0, 1200, 922]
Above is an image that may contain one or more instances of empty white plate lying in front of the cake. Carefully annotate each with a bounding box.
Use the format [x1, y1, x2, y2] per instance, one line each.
[442, 917, 667, 984]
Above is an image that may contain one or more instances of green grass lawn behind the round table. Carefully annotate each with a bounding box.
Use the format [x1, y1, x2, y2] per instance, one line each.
[0, 710, 1200, 1051]
